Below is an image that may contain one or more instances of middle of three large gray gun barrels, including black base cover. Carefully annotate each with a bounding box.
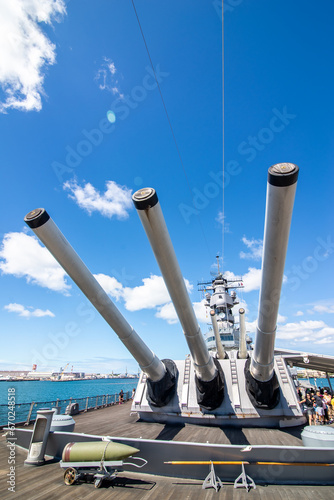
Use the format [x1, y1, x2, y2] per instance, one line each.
[132, 188, 224, 410]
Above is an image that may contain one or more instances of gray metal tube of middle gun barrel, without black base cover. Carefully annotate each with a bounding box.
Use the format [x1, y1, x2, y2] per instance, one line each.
[133, 188, 217, 381]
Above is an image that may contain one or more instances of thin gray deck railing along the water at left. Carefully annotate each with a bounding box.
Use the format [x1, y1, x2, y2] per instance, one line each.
[0, 391, 132, 429]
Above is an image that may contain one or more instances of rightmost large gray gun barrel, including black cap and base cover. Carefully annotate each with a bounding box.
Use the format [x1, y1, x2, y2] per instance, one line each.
[246, 163, 299, 409]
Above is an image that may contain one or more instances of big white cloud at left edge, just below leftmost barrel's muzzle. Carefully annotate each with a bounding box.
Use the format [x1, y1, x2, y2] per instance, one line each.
[0, 233, 71, 295]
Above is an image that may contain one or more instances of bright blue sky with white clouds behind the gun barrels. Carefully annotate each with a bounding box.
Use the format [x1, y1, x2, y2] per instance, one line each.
[0, 0, 334, 373]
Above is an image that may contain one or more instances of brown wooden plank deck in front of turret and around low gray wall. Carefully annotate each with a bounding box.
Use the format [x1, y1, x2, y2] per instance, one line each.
[0, 403, 334, 500]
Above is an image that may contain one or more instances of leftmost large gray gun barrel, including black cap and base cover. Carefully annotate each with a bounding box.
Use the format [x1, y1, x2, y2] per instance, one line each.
[24, 208, 175, 406]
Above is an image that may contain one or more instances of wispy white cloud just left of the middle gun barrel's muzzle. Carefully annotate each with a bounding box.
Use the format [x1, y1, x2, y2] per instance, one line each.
[63, 181, 132, 219]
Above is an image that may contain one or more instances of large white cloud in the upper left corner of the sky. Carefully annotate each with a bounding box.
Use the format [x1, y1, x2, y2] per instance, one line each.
[0, 0, 66, 113]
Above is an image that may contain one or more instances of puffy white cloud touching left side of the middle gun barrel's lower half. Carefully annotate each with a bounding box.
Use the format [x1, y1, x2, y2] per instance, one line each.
[123, 274, 170, 311]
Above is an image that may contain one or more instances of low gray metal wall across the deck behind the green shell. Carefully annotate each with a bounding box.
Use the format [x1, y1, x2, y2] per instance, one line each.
[11, 429, 334, 485]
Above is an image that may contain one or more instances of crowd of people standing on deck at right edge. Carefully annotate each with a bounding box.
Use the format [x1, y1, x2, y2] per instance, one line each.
[298, 389, 334, 425]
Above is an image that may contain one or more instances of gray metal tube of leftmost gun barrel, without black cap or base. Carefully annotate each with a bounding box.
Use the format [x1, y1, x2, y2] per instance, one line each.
[24, 214, 166, 381]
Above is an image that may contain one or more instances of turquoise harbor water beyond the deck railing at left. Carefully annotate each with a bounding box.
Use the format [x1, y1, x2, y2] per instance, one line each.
[0, 379, 138, 426]
